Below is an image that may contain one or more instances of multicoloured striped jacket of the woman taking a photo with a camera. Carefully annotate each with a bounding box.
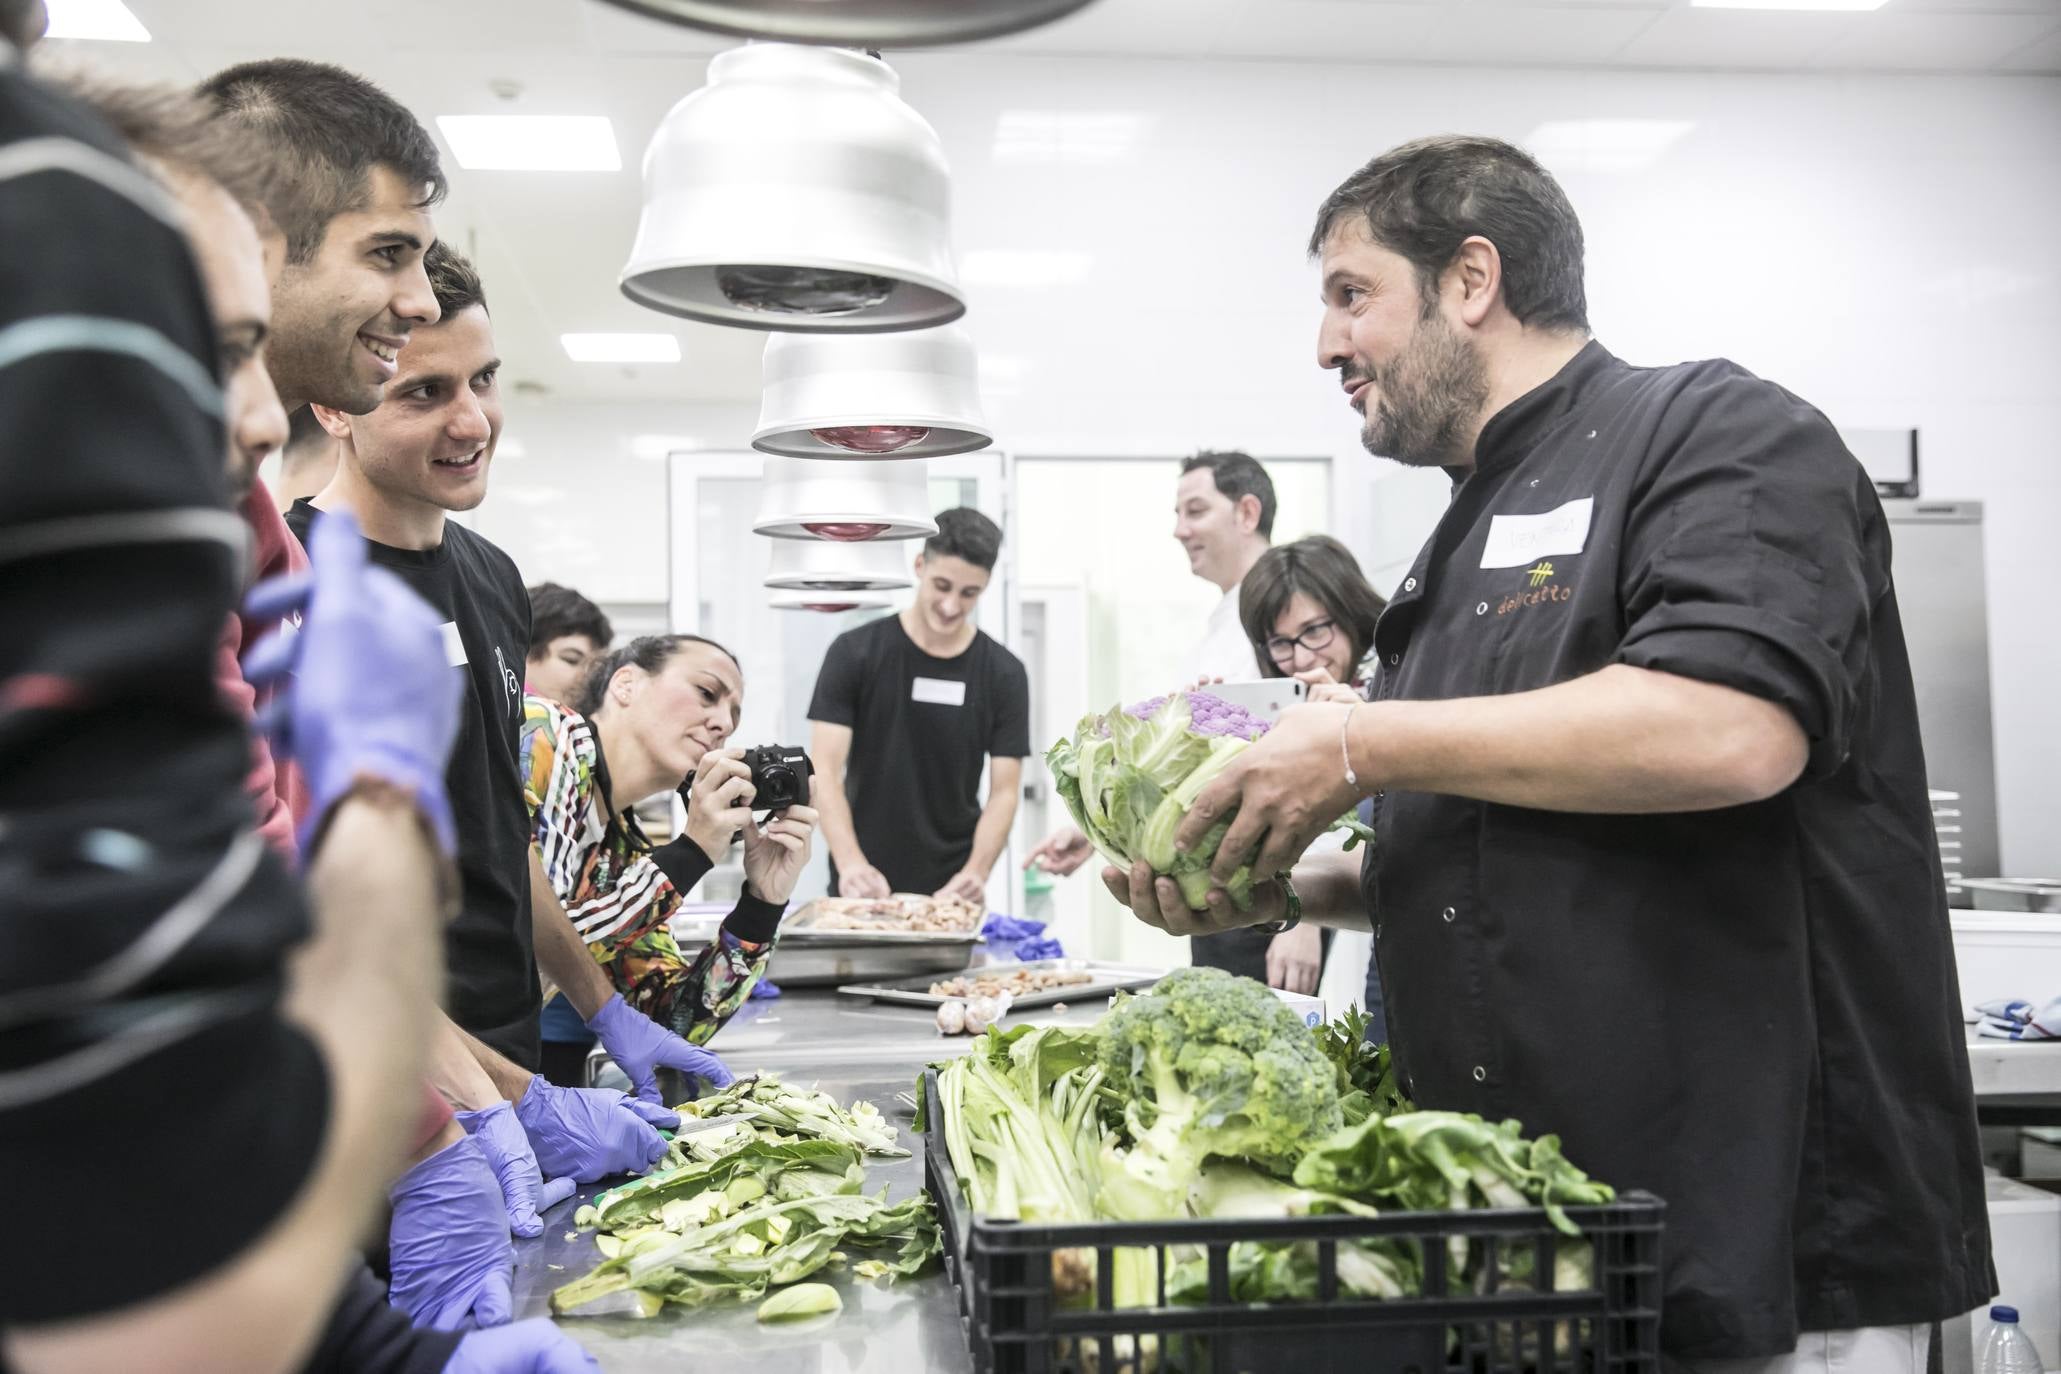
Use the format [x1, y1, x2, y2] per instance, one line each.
[521, 696, 777, 1044]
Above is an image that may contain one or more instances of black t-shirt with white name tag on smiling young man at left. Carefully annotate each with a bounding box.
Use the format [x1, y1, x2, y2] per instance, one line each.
[286, 501, 542, 1069]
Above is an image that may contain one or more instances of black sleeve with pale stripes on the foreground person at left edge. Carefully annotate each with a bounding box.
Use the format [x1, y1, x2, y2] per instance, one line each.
[0, 41, 328, 1325]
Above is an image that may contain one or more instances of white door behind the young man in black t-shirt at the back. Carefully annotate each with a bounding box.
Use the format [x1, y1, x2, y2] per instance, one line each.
[666, 451, 1022, 911]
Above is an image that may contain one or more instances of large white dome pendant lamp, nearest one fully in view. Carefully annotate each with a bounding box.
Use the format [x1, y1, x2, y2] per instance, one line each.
[620, 43, 967, 332]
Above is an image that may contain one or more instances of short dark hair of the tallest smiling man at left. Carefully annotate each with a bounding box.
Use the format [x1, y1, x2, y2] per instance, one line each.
[200, 58, 447, 264]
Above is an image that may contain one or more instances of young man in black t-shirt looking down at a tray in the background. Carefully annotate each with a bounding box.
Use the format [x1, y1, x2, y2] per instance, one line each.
[808, 507, 1031, 902]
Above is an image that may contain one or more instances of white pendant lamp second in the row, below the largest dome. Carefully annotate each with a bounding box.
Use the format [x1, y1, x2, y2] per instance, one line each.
[752, 323, 995, 457]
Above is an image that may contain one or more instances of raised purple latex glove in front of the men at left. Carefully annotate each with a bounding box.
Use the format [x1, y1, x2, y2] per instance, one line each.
[243, 511, 464, 855]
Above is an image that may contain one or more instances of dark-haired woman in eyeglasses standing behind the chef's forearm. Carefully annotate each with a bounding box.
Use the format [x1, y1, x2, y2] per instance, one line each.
[1239, 534, 1389, 1040]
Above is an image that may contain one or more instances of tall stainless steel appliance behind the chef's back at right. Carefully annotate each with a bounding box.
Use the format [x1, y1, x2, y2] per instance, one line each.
[1882, 501, 2001, 885]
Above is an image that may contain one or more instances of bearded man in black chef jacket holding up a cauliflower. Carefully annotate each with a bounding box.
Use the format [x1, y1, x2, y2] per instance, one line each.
[1105, 138, 1995, 1374]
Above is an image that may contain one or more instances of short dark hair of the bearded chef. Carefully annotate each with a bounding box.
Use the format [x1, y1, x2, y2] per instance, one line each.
[1309, 134, 1589, 330]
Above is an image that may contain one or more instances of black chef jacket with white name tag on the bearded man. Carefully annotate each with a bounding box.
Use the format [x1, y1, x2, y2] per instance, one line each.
[1364, 342, 1995, 1360]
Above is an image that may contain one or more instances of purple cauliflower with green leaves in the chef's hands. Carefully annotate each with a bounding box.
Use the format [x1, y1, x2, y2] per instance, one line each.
[1045, 690, 1373, 911]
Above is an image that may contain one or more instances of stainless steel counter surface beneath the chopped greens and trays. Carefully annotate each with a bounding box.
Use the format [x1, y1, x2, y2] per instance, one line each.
[515, 991, 1105, 1374]
